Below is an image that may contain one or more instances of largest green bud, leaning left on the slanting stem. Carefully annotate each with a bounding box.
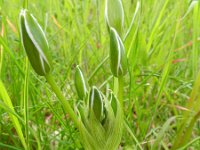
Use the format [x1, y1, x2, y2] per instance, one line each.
[20, 10, 50, 76]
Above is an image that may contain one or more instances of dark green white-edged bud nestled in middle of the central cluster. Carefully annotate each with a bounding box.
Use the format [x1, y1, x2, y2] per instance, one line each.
[89, 87, 103, 121]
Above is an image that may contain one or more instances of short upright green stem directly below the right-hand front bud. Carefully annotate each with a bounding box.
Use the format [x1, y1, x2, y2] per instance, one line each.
[118, 76, 124, 108]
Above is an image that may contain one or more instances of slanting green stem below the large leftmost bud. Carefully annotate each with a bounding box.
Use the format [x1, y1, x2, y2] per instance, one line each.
[45, 74, 80, 128]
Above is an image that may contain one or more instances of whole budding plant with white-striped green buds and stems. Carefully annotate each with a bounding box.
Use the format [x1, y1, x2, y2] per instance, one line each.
[20, 0, 127, 150]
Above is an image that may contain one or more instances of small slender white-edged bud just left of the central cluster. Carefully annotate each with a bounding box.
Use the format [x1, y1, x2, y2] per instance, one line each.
[75, 66, 87, 100]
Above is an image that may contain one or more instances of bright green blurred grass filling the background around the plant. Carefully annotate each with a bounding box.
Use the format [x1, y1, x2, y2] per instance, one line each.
[0, 0, 200, 149]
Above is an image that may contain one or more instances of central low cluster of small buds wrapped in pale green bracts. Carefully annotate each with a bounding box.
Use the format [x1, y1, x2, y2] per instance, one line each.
[75, 67, 123, 150]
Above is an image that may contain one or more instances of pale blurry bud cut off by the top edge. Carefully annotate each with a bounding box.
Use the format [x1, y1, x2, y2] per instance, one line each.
[105, 0, 124, 35]
